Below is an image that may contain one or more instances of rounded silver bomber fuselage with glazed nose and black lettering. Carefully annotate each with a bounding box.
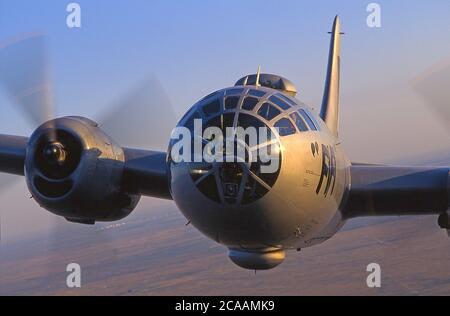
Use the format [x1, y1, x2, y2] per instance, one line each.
[168, 85, 350, 268]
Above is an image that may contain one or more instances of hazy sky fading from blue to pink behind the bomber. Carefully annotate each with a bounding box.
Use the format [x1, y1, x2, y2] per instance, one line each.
[0, 0, 450, 238]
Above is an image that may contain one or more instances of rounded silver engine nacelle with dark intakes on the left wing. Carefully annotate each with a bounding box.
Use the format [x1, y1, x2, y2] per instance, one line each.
[25, 117, 140, 224]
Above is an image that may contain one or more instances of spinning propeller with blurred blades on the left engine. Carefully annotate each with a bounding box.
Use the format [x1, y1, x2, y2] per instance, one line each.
[0, 34, 176, 258]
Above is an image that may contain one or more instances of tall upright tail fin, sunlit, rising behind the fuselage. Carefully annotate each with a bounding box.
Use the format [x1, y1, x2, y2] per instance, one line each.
[320, 16, 341, 136]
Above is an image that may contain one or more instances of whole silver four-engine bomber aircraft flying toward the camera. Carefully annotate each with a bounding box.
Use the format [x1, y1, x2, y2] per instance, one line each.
[0, 17, 450, 270]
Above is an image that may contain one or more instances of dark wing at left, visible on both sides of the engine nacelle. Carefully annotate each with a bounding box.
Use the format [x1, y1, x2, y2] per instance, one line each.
[0, 135, 172, 199]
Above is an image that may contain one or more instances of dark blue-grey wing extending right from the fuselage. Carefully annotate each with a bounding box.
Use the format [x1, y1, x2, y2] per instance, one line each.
[343, 164, 450, 219]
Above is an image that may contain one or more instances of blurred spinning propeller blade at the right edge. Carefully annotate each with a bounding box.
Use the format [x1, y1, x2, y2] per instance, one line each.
[412, 59, 450, 129]
